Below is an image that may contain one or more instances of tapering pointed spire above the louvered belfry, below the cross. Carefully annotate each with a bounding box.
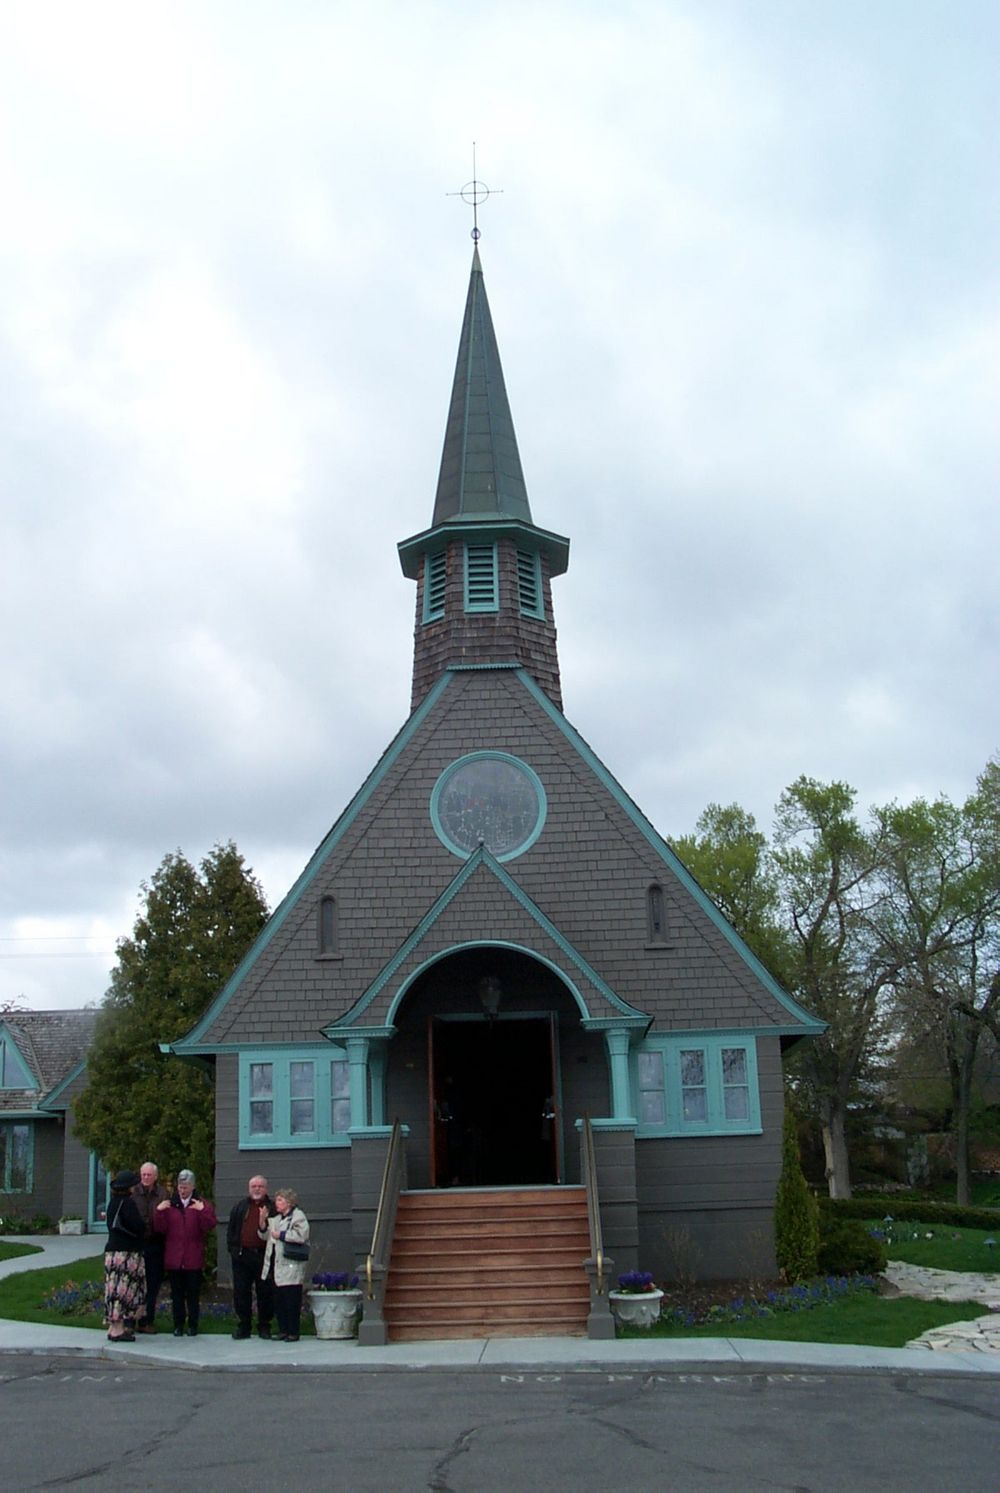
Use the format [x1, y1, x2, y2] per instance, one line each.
[433, 246, 531, 527]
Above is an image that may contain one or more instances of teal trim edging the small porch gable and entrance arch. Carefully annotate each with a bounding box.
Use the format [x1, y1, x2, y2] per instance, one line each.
[324, 847, 649, 1036]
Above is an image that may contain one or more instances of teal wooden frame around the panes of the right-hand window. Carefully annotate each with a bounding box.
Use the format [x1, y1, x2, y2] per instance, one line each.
[631, 1032, 763, 1138]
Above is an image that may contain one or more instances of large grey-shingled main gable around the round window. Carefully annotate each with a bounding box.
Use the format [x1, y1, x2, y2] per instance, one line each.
[172, 666, 822, 1053]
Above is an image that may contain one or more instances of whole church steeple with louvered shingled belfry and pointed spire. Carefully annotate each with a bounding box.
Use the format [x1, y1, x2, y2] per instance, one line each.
[399, 246, 569, 709]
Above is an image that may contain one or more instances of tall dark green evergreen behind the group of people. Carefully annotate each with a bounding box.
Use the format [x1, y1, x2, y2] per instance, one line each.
[73, 842, 267, 1188]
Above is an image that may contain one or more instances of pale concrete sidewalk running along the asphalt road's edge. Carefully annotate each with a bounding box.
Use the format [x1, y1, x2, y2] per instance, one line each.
[0, 1235, 1000, 1375]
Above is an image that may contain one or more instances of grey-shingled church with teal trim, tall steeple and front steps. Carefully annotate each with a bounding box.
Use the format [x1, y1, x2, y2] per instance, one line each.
[173, 246, 822, 1341]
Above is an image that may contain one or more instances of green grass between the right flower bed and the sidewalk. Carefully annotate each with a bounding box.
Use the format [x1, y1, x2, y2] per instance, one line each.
[619, 1291, 985, 1348]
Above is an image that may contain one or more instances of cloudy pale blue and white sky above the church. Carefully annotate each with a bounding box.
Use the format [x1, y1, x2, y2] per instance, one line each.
[0, 0, 1000, 1009]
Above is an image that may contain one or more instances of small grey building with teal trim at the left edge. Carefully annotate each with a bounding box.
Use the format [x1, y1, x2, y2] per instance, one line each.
[0, 1011, 106, 1227]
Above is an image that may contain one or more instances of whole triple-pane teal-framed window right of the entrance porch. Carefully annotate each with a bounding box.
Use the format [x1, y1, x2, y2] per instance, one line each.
[631, 1032, 763, 1138]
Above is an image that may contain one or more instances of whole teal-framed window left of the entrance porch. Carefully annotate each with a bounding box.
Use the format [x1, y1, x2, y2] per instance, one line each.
[239, 1042, 351, 1151]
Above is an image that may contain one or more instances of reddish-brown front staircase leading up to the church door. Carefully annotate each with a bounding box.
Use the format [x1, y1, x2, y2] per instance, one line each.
[384, 1187, 590, 1342]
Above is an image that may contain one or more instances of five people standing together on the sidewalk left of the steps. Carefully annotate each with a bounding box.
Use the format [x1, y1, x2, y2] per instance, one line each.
[104, 1162, 309, 1342]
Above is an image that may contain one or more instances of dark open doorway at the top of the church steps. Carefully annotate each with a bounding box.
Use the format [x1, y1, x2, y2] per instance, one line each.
[430, 1018, 558, 1187]
